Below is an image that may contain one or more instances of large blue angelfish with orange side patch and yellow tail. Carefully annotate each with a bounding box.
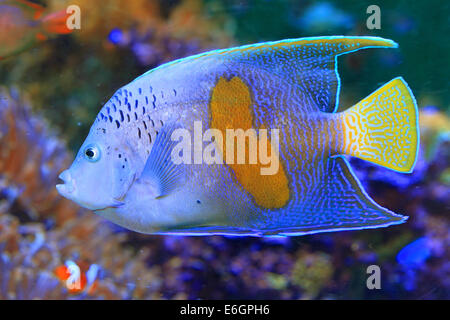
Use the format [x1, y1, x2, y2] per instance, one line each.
[57, 36, 419, 236]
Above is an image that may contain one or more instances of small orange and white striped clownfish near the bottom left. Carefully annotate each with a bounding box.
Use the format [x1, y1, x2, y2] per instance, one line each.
[53, 260, 99, 295]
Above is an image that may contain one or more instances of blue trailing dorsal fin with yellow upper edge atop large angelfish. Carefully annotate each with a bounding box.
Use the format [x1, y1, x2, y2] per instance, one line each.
[214, 36, 397, 112]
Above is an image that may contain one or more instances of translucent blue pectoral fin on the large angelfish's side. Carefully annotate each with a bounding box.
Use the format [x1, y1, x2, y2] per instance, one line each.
[139, 124, 183, 199]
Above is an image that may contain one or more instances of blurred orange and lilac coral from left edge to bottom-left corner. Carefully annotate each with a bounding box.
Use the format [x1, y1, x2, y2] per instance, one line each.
[0, 89, 158, 299]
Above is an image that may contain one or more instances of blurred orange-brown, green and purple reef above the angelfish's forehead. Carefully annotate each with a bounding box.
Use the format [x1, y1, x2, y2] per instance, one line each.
[0, 0, 233, 149]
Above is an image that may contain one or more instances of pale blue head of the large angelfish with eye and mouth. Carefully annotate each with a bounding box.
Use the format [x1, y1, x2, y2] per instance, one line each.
[56, 125, 135, 210]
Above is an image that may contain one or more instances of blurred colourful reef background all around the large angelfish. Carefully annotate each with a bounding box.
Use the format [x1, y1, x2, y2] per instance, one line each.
[0, 0, 450, 299]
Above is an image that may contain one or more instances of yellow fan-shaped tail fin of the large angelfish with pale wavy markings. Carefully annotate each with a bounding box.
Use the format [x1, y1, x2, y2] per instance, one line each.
[340, 77, 419, 172]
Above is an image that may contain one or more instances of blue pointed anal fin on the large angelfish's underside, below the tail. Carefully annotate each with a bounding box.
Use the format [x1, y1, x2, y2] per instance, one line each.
[257, 156, 407, 236]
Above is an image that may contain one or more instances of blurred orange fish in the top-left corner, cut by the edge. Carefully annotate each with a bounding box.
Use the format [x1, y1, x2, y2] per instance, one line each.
[0, 0, 72, 60]
